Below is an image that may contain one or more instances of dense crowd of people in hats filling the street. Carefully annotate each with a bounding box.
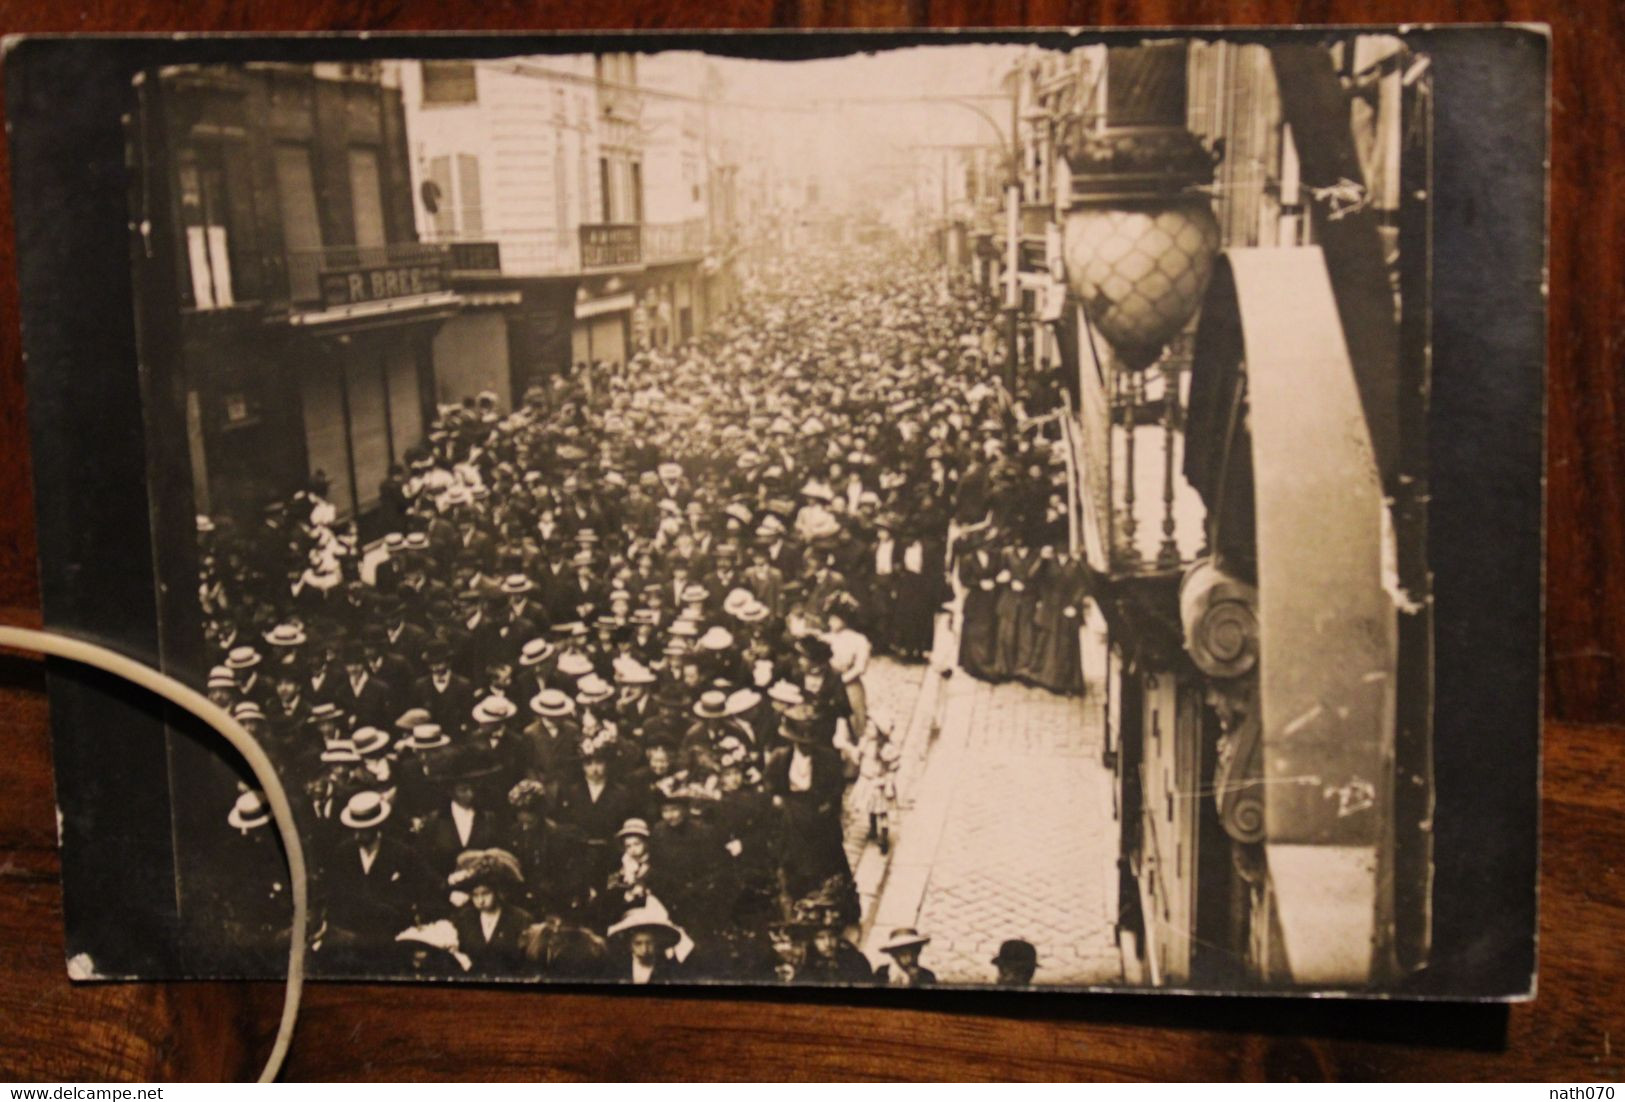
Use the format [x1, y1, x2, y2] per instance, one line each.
[198, 252, 1087, 985]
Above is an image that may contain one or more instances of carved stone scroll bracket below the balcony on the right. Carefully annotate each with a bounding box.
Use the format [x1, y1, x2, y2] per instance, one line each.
[1180, 559, 1264, 842]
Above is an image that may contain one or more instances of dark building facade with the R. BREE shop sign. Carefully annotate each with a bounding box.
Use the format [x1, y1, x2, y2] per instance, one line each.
[137, 63, 460, 527]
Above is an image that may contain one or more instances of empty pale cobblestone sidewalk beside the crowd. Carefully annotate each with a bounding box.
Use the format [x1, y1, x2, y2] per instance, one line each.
[866, 673, 1121, 985]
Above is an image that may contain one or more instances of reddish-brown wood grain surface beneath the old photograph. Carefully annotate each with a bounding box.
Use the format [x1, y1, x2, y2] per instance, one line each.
[0, 0, 1625, 1082]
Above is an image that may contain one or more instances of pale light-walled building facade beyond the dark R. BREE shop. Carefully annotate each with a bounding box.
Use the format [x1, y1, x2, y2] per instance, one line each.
[401, 54, 733, 406]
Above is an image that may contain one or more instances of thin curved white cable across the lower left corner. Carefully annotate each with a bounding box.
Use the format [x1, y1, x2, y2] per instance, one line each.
[0, 624, 309, 1082]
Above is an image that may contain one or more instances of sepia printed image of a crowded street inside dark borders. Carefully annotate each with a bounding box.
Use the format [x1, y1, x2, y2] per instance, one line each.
[9, 28, 1539, 996]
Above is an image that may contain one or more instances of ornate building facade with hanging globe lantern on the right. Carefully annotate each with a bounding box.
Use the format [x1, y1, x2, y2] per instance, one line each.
[995, 34, 1432, 987]
